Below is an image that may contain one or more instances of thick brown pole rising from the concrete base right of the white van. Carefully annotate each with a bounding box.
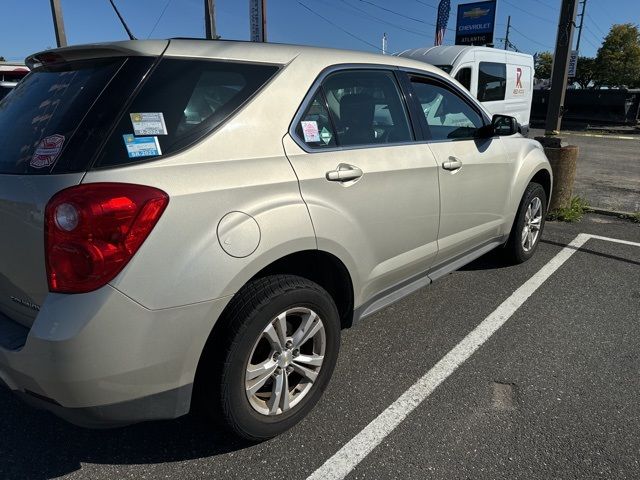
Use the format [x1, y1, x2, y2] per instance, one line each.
[545, 0, 578, 135]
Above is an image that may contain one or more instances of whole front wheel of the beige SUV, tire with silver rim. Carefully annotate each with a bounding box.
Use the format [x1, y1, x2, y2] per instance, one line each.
[504, 182, 547, 264]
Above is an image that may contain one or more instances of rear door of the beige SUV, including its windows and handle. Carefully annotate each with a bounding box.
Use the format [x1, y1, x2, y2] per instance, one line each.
[284, 68, 440, 308]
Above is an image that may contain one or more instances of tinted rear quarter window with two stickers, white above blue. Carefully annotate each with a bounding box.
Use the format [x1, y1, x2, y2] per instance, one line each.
[94, 59, 278, 168]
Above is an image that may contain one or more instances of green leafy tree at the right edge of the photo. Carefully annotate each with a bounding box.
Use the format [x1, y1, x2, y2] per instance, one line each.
[596, 23, 640, 88]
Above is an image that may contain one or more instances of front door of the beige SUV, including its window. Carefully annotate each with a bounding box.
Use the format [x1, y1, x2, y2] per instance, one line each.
[408, 74, 513, 265]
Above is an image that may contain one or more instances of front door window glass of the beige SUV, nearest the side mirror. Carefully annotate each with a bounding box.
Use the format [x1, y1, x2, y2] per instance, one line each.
[411, 78, 484, 140]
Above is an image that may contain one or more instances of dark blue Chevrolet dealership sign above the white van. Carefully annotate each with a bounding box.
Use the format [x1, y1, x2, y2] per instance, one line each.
[456, 0, 496, 45]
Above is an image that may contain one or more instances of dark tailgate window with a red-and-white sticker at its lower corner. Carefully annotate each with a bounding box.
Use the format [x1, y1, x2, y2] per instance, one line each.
[0, 59, 124, 173]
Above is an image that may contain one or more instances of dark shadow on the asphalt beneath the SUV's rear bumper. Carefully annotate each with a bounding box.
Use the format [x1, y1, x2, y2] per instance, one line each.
[0, 389, 253, 479]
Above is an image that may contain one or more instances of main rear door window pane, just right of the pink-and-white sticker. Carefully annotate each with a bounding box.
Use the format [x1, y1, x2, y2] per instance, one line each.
[323, 70, 413, 146]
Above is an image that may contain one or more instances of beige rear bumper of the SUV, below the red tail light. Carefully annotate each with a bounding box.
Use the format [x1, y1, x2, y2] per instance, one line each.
[0, 286, 228, 427]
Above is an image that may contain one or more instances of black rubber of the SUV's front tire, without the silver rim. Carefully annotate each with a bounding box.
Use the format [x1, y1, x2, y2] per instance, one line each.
[504, 182, 547, 264]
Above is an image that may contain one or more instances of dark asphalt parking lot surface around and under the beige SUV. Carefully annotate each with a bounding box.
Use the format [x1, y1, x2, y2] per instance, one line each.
[0, 215, 640, 479]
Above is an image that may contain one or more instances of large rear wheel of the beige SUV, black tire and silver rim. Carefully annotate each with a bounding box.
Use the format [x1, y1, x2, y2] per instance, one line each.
[196, 275, 340, 441]
